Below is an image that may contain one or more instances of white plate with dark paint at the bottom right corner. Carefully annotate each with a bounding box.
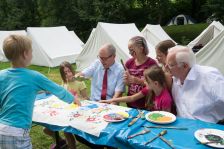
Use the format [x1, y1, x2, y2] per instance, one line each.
[194, 128, 224, 148]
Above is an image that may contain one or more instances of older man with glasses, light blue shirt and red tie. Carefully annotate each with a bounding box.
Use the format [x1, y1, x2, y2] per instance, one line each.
[76, 44, 125, 101]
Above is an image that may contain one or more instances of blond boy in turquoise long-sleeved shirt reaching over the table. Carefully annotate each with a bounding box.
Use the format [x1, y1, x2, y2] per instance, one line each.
[0, 35, 80, 149]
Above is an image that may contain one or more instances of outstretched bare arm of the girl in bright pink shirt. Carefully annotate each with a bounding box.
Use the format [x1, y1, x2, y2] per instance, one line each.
[100, 92, 145, 103]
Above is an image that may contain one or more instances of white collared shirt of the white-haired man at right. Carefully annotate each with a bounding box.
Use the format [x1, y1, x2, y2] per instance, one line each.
[172, 65, 224, 123]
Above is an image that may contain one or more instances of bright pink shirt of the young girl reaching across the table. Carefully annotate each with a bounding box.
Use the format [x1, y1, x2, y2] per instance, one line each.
[141, 87, 173, 111]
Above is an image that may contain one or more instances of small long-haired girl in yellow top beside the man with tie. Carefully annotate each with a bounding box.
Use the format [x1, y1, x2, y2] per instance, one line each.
[44, 61, 88, 149]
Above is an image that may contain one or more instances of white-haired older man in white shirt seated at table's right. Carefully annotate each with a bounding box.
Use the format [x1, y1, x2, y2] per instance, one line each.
[166, 46, 224, 123]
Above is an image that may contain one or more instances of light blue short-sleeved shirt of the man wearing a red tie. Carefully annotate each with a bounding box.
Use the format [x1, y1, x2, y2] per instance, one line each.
[82, 60, 125, 101]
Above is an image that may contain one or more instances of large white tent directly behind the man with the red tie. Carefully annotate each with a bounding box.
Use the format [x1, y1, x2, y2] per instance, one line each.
[76, 23, 155, 71]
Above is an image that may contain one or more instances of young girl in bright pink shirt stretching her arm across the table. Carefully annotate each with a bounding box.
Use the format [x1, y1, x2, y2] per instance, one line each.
[100, 65, 173, 112]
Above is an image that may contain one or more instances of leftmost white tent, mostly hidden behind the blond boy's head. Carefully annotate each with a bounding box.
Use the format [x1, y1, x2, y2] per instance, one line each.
[0, 30, 26, 62]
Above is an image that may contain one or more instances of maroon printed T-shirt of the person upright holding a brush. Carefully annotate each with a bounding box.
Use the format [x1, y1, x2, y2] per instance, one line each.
[125, 57, 157, 109]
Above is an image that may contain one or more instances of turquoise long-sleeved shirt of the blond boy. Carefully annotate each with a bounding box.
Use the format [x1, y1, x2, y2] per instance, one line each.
[0, 68, 74, 129]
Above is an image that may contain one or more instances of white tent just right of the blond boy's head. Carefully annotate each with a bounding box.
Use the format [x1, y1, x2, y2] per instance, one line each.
[27, 26, 82, 67]
